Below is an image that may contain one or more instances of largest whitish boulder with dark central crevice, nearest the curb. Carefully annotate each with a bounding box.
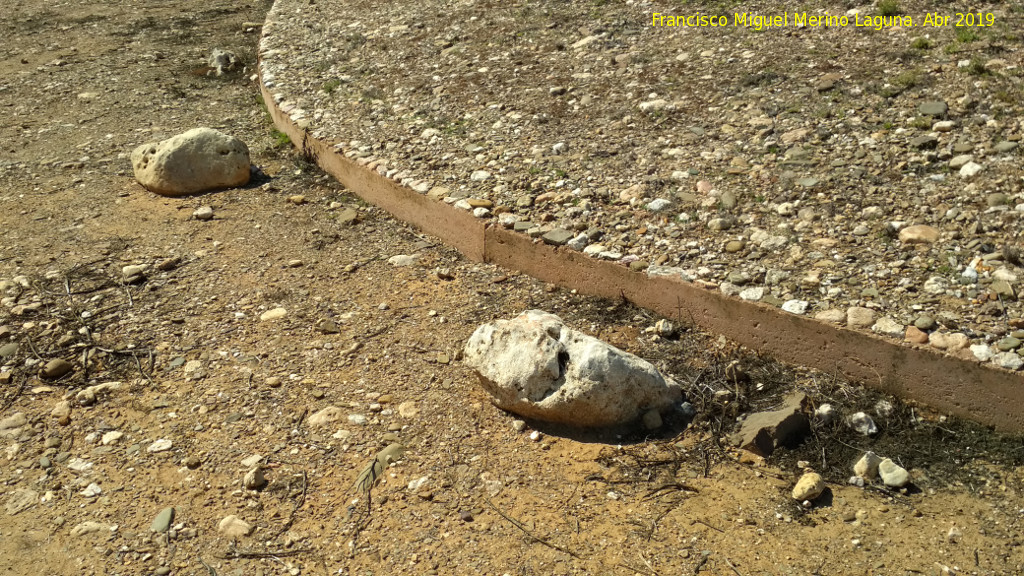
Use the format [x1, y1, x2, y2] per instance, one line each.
[464, 310, 683, 427]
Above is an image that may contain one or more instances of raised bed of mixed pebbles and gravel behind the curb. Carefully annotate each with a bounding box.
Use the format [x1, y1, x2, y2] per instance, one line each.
[260, 0, 1024, 370]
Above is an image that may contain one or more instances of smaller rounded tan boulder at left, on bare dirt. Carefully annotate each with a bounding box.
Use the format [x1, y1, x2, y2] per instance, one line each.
[131, 128, 249, 196]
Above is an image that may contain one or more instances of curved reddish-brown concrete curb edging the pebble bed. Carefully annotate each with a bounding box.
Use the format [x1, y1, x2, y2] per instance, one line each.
[259, 16, 1024, 431]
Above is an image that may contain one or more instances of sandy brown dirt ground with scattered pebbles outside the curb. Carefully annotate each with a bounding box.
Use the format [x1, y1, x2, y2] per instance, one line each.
[6, 0, 1024, 576]
